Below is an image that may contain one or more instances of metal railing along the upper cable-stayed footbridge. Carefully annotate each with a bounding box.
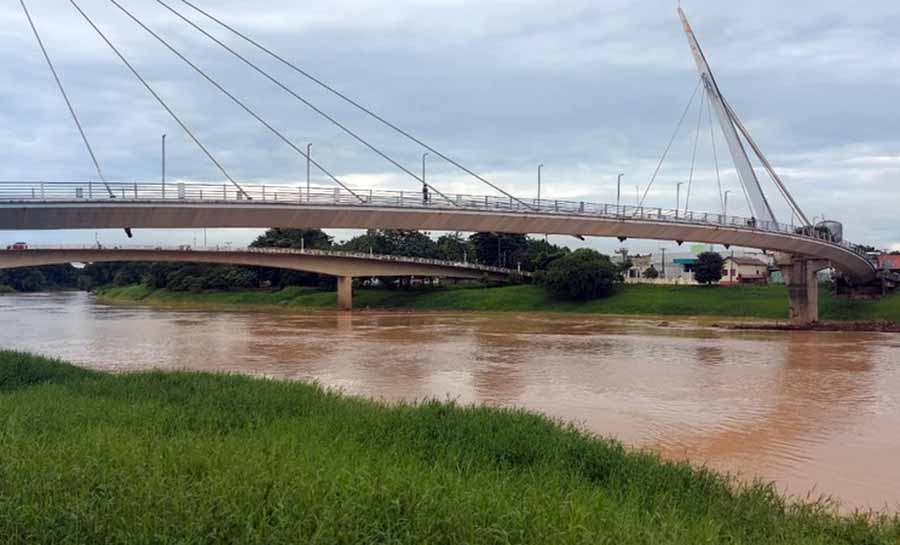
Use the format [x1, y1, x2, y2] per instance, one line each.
[0, 181, 865, 262]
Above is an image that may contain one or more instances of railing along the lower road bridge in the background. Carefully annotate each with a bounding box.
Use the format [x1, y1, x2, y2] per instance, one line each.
[0, 243, 531, 276]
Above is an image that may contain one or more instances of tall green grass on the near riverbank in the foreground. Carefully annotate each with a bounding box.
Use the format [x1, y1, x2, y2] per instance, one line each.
[0, 352, 900, 545]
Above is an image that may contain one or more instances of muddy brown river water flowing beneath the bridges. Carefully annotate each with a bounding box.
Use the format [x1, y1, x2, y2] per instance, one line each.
[0, 293, 900, 511]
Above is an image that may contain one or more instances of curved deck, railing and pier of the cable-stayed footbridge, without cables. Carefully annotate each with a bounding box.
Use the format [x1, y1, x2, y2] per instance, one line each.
[0, 182, 876, 323]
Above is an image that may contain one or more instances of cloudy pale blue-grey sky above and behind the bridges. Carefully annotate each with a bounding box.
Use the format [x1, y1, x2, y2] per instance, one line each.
[0, 0, 900, 252]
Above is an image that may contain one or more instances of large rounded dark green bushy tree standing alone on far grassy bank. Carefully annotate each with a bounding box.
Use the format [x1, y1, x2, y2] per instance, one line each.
[541, 248, 619, 301]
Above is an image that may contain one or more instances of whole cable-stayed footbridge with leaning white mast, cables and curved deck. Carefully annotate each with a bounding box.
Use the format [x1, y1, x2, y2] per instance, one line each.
[0, 0, 877, 323]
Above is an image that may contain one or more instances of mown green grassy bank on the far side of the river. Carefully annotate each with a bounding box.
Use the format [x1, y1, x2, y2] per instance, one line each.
[99, 284, 900, 321]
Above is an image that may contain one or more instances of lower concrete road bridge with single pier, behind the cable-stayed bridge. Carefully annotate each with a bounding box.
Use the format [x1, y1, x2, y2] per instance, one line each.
[0, 245, 530, 310]
